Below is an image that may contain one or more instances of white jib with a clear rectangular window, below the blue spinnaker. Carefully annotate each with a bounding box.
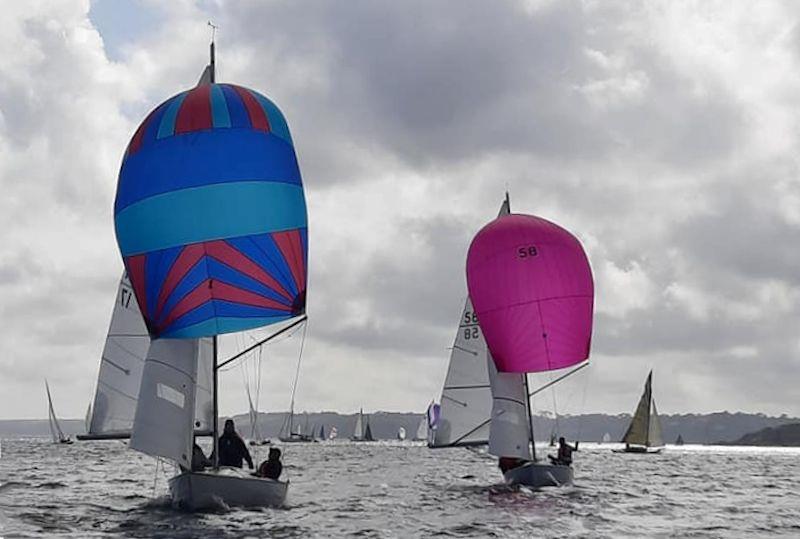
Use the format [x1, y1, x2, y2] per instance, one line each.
[130, 339, 200, 468]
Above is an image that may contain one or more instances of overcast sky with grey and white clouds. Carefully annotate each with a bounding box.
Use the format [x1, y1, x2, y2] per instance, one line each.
[0, 0, 800, 419]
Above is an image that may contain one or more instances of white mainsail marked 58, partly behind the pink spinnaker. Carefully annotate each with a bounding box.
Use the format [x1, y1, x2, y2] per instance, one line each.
[429, 298, 492, 447]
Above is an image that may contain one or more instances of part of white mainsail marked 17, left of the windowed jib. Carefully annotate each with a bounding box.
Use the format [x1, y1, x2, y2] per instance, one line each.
[88, 274, 150, 436]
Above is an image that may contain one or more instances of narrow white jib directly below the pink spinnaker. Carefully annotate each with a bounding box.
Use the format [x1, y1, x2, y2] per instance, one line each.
[489, 359, 533, 460]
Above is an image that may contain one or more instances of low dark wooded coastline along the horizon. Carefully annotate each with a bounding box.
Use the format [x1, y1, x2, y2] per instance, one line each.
[0, 412, 800, 445]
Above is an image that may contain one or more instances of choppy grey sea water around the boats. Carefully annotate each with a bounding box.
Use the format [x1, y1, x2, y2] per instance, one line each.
[0, 440, 800, 538]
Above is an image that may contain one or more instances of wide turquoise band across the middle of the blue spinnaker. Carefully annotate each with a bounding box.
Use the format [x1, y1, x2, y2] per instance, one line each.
[115, 181, 307, 256]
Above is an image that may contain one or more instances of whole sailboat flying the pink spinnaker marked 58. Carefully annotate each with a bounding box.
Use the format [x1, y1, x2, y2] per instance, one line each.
[429, 194, 593, 488]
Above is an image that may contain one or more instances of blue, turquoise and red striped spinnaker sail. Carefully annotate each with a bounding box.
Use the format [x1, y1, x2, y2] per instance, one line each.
[114, 84, 308, 338]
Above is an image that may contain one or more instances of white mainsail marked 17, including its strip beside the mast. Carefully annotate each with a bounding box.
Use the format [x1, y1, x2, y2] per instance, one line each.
[87, 274, 214, 438]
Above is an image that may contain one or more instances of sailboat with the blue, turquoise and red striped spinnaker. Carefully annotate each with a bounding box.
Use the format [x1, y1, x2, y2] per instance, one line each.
[105, 40, 308, 509]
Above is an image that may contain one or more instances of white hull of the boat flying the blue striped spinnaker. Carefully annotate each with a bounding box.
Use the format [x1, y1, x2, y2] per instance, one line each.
[169, 467, 289, 511]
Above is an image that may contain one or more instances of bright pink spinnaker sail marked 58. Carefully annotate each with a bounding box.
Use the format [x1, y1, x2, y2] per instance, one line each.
[467, 214, 594, 372]
